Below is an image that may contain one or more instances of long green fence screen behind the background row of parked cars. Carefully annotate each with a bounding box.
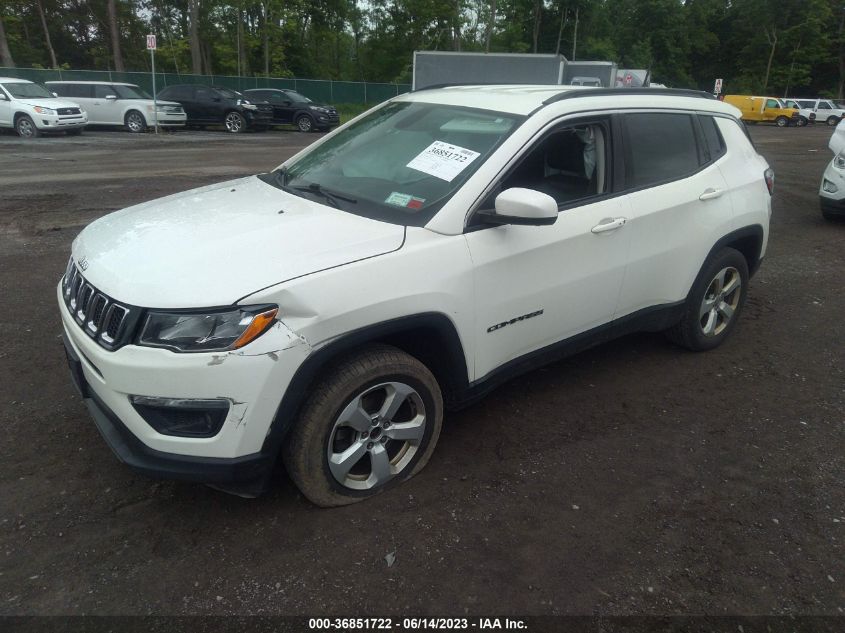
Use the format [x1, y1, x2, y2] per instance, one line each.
[0, 67, 411, 103]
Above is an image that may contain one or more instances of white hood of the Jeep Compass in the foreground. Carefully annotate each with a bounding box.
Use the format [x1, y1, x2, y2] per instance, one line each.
[73, 176, 405, 308]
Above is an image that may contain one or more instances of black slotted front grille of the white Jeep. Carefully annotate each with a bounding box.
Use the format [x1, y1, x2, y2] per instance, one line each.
[62, 258, 138, 350]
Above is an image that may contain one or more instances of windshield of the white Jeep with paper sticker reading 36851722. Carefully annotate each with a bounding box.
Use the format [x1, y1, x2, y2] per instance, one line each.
[265, 103, 522, 226]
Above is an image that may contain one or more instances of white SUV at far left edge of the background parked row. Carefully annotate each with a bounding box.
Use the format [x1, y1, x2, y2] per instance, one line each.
[0, 77, 88, 138]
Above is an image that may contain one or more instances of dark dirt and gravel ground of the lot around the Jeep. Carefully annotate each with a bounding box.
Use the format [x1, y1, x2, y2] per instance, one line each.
[0, 121, 845, 616]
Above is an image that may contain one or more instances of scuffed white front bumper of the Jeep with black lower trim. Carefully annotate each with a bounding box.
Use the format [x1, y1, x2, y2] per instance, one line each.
[58, 287, 311, 484]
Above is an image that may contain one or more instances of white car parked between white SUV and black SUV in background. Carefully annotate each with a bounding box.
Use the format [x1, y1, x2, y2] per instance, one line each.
[45, 81, 187, 133]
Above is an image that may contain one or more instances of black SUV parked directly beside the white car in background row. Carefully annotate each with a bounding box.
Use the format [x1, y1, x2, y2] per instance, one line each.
[158, 84, 273, 133]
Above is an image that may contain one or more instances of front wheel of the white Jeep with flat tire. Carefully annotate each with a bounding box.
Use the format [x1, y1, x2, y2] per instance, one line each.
[282, 345, 443, 507]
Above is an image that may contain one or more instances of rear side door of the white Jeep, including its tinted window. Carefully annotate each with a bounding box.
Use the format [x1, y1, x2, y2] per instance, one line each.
[617, 111, 733, 317]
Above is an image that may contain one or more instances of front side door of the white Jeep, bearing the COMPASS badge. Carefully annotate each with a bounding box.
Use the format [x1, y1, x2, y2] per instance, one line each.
[466, 117, 631, 380]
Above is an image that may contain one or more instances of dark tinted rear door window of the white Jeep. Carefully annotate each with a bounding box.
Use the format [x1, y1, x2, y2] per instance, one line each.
[622, 112, 700, 189]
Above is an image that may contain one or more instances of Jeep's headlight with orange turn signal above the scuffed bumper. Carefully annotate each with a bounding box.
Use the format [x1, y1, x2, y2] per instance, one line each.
[138, 305, 279, 352]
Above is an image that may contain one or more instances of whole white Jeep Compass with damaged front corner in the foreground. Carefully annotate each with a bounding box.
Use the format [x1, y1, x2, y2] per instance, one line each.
[57, 86, 773, 506]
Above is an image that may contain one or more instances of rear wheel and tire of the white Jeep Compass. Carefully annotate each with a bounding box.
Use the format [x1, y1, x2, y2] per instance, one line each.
[666, 248, 748, 352]
